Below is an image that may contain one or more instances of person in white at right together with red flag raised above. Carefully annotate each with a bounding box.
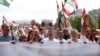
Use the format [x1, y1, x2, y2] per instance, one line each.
[80, 9, 95, 43]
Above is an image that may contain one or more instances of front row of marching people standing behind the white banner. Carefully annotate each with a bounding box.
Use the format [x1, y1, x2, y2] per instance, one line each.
[0, 24, 100, 44]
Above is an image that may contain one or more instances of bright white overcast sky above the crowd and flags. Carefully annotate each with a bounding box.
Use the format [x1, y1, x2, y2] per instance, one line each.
[0, 0, 100, 23]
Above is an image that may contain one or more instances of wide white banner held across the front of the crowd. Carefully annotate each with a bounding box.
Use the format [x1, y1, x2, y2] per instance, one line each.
[0, 42, 100, 56]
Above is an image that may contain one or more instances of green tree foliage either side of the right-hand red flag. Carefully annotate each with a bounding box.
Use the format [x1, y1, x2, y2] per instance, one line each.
[69, 15, 99, 31]
